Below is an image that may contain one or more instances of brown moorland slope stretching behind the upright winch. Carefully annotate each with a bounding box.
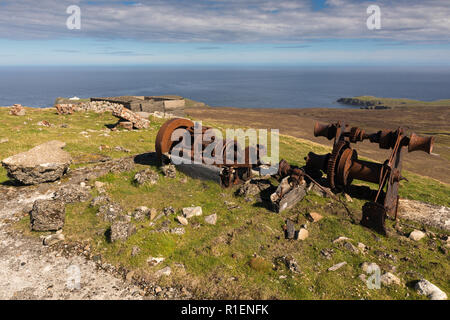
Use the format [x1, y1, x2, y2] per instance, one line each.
[186, 107, 450, 183]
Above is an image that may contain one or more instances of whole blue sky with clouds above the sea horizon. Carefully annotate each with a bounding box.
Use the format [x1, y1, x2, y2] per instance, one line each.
[0, 0, 450, 67]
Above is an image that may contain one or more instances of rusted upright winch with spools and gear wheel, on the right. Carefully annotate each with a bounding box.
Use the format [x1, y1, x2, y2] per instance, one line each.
[306, 122, 434, 234]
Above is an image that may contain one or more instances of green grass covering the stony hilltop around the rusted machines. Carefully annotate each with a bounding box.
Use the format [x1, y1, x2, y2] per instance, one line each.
[0, 108, 450, 299]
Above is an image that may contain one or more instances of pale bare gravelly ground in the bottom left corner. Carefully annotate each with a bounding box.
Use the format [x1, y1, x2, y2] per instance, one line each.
[0, 158, 142, 300]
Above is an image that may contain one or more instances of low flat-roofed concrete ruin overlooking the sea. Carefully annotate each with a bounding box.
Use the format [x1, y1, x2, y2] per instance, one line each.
[91, 95, 186, 115]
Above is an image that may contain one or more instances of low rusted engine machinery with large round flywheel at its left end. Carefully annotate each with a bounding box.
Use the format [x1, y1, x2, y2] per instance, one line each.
[155, 118, 265, 187]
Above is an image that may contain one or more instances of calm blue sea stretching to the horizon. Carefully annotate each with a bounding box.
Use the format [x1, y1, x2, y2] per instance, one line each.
[0, 66, 450, 108]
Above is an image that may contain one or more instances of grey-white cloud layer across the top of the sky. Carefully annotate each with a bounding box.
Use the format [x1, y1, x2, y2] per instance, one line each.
[0, 0, 450, 43]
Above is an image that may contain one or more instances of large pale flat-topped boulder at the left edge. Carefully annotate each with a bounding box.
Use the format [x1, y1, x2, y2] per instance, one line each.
[2, 141, 72, 185]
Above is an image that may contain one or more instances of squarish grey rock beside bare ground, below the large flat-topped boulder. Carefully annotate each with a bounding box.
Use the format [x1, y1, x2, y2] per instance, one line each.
[30, 200, 66, 231]
